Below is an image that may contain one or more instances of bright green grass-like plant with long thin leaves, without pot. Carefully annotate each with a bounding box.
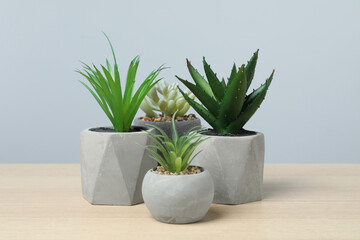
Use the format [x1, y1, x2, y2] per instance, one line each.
[76, 33, 164, 132]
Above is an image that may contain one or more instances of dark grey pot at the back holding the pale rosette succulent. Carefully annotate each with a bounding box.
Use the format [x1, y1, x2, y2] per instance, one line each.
[134, 118, 201, 138]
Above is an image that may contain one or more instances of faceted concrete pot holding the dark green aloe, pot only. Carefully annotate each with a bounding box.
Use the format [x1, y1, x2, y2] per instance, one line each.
[192, 133, 264, 204]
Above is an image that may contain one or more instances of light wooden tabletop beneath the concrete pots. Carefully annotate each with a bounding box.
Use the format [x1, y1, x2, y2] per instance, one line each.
[0, 164, 360, 240]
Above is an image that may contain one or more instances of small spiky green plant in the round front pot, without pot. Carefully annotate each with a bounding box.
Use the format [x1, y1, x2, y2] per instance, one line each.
[145, 114, 207, 174]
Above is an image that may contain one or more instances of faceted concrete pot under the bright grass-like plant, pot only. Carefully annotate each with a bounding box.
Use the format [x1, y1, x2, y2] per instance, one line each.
[80, 128, 157, 205]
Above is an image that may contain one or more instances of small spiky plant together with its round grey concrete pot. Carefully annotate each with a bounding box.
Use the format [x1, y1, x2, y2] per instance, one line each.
[142, 114, 214, 223]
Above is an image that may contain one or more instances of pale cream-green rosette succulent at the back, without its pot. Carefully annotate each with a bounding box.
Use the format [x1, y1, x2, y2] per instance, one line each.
[140, 80, 195, 117]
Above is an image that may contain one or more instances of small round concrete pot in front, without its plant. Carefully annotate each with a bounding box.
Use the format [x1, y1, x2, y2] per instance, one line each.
[142, 168, 214, 223]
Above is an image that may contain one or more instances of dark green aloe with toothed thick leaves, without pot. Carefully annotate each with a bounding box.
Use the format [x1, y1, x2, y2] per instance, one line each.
[176, 50, 274, 134]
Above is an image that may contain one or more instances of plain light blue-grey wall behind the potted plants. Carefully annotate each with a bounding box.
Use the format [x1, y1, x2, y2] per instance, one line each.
[0, 0, 360, 163]
